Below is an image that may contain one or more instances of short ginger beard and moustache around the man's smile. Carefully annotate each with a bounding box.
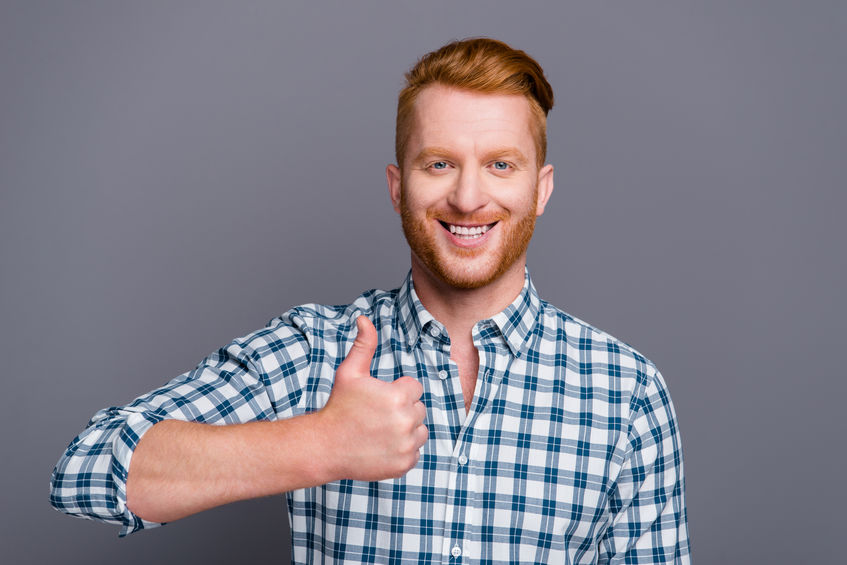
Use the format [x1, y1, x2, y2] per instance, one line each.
[400, 188, 538, 290]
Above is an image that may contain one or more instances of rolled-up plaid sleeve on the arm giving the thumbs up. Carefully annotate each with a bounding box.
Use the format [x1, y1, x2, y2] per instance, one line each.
[50, 318, 310, 537]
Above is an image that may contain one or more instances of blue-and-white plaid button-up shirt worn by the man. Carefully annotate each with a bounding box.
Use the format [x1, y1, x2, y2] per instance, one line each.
[51, 275, 689, 564]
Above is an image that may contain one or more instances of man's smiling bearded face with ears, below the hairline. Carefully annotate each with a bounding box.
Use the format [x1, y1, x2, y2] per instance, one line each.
[386, 85, 553, 289]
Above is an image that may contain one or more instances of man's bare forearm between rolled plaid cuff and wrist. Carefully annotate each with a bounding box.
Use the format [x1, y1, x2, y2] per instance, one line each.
[126, 413, 340, 522]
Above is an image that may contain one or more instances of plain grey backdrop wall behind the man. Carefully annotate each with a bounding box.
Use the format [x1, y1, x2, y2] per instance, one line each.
[0, 0, 847, 564]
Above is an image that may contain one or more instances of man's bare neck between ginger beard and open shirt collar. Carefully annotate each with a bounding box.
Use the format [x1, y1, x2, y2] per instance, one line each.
[412, 255, 526, 340]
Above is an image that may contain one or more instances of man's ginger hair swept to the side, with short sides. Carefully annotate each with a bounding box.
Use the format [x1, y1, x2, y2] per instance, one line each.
[394, 37, 553, 168]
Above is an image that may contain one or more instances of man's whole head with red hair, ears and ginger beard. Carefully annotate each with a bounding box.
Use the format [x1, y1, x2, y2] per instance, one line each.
[386, 39, 553, 292]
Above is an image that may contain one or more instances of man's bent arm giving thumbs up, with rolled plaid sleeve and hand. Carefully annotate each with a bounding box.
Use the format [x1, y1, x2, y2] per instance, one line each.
[51, 317, 427, 535]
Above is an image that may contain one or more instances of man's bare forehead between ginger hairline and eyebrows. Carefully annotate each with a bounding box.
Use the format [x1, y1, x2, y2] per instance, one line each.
[408, 85, 535, 159]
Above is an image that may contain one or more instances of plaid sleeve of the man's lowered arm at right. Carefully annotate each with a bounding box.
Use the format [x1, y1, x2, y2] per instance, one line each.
[599, 372, 690, 565]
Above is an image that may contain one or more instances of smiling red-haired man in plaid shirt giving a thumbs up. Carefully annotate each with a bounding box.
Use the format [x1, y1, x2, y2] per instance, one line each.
[51, 39, 689, 563]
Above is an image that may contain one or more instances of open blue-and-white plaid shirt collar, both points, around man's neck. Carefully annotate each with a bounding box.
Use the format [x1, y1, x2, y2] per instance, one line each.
[397, 268, 541, 357]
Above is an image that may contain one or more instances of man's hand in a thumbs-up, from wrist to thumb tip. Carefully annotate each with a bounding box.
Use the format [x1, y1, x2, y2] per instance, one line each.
[318, 316, 428, 481]
